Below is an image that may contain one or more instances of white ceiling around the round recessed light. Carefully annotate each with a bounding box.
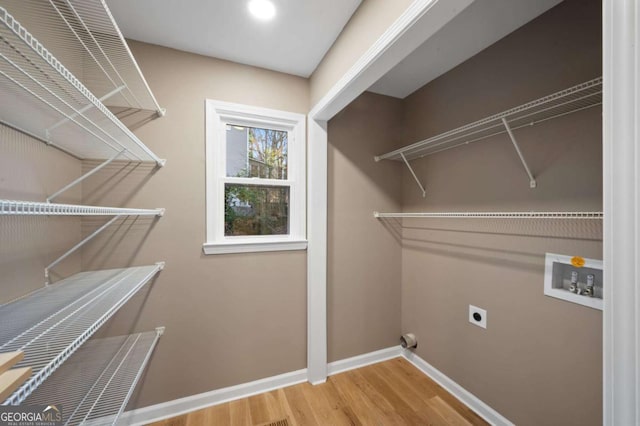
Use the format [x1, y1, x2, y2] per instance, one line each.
[106, 0, 362, 77]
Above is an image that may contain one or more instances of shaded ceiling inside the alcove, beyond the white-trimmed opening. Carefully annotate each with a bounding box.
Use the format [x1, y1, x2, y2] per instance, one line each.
[369, 0, 562, 98]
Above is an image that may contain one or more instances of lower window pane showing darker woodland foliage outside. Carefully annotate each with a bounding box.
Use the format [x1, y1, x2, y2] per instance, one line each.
[224, 183, 289, 237]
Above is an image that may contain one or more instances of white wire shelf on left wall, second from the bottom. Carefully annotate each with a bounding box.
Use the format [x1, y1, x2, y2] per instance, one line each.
[0, 262, 164, 405]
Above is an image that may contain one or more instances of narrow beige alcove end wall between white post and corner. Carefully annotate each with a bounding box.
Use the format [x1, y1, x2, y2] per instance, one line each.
[327, 93, 402, 362]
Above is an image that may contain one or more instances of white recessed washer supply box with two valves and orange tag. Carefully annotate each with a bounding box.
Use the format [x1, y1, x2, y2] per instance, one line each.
[544, 253, 603, 310]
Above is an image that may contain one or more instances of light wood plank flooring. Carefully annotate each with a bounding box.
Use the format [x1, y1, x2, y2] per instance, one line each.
[153, 358, 487, 426]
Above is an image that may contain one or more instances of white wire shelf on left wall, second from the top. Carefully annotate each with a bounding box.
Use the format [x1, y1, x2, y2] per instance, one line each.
[0, 7, 164, 166]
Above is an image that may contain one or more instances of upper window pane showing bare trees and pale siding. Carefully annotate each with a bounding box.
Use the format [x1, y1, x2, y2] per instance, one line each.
[227, 125, 289, 179]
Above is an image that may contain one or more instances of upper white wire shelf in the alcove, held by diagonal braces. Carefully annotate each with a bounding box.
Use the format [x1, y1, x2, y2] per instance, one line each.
[375, 77, 602, 161]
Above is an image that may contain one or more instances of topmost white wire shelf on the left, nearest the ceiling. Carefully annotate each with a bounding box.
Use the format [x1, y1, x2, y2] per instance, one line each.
[2, 0, 164, 115]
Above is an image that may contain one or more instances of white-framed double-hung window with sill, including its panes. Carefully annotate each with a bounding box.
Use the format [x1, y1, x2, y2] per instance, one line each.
[204, 100, 307, 254]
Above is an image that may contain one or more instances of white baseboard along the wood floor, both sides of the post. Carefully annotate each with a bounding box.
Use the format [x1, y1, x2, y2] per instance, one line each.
[118, 346, 513, 426]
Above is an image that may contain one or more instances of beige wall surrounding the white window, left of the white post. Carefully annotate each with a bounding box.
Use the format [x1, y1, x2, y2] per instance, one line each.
[83, 43, 309, 407]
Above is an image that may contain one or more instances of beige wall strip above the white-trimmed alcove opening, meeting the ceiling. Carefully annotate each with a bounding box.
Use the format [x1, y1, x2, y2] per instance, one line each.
[310, 0, 412, 108]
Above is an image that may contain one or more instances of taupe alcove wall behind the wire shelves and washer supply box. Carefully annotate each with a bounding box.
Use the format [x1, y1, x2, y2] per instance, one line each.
[402, 0, 602, 426]
